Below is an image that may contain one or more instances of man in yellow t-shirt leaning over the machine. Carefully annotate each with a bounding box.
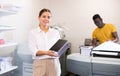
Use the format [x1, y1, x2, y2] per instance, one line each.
[92, 14, 119, 47]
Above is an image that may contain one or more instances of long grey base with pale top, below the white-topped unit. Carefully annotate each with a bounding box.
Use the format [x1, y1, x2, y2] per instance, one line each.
[67, 53, 120, 76]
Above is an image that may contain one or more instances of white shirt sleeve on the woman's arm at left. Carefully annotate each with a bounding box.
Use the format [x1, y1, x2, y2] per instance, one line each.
[28, 32, 38, 56]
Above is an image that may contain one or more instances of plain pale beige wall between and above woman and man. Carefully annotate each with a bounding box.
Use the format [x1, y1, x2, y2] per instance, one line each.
[50, 0, 120, 52]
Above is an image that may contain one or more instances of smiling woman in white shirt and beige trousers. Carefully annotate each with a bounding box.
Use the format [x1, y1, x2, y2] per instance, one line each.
[29, 9, 61, 76]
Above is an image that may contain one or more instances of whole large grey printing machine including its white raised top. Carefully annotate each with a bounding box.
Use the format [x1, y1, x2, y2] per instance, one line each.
[67, 41, 120, 76]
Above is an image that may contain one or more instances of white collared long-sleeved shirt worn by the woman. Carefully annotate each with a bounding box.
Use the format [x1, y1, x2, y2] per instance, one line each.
[29, 27, 60, 59]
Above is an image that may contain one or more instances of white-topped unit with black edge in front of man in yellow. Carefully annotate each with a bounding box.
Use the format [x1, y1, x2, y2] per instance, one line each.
[92, 41, 120, 57]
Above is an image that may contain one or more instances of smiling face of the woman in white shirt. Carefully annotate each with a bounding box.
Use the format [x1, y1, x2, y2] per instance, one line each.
[39, 12, 51, 26]
